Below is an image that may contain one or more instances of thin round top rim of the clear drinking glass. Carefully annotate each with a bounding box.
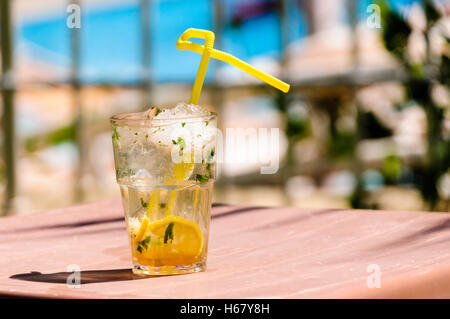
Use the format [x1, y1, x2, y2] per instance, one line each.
[109, 112, 217, 127]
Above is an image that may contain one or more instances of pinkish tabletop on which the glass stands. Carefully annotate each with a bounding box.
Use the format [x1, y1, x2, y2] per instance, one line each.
[0, 200, 450, 298]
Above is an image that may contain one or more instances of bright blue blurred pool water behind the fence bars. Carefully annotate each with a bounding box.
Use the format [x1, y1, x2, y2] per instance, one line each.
[16, 0, 422, 83]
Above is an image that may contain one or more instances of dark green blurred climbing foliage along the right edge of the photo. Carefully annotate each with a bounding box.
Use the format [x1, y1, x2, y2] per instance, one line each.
[378, 0, 450, 209]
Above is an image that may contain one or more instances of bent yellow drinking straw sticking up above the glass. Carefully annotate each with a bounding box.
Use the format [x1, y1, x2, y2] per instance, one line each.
[177, 28, 290, 104]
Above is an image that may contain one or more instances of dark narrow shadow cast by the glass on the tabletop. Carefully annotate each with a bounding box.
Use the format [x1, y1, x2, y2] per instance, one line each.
[9, 268, 145, 284]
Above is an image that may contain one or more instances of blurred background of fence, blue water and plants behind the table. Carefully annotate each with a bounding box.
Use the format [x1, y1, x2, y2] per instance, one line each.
[0, 0, 450, 215]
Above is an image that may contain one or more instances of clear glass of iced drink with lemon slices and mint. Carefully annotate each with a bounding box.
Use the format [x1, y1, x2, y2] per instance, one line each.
[111, 103, 217, 275]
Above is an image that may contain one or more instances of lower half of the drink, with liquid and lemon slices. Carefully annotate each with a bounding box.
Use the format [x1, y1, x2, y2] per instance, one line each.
[120, 181, 213, 274]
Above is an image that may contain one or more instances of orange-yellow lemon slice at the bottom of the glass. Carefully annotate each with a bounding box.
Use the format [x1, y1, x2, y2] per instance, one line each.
[136, 215, 203, 266]
